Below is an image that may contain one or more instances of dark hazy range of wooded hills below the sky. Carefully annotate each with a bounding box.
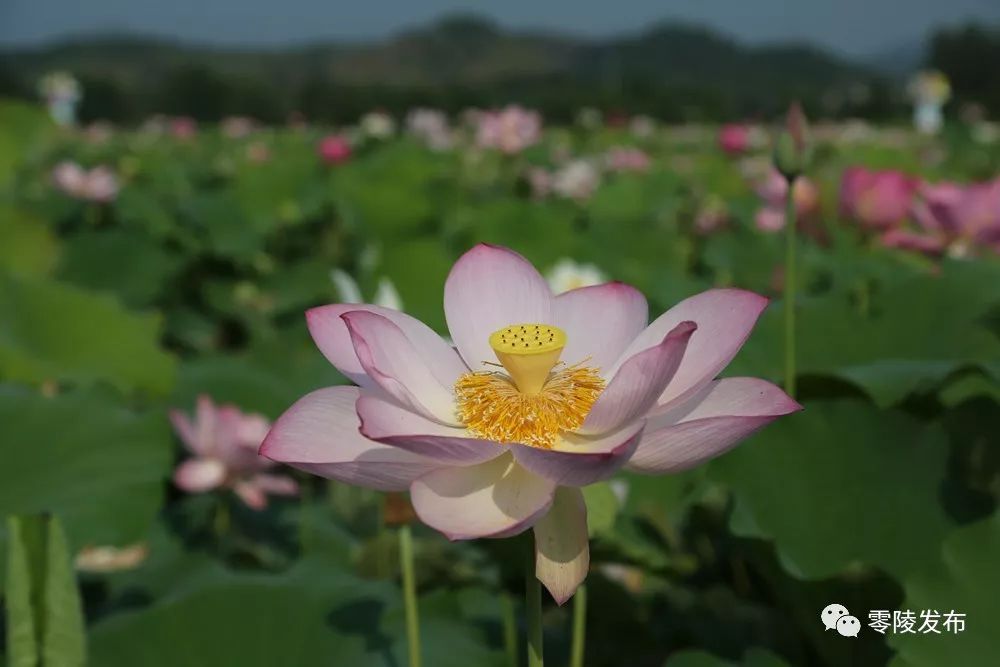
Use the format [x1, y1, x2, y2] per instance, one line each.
[0, 16, 892, 122]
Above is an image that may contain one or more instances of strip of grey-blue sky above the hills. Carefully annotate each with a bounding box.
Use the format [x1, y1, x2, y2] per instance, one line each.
[0, 0, 1000, 55]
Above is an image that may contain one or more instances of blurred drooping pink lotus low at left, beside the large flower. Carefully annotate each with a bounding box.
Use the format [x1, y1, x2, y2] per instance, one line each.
[170, 396, 299, 510]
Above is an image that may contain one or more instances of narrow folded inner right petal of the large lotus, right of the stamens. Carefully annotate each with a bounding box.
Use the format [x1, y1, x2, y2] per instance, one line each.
[579, 322, 697, 435]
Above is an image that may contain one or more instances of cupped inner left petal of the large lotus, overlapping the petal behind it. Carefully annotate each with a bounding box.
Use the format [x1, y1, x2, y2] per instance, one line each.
[341, 310, 458, 424]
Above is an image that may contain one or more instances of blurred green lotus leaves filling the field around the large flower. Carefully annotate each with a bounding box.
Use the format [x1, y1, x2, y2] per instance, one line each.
[0, 103, 1000, 667]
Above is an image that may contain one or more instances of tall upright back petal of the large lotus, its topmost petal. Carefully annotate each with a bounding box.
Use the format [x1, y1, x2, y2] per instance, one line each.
[444, 243, 552, 371]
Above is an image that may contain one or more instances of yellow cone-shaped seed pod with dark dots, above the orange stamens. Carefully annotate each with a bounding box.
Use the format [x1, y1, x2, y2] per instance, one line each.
[490, 324, 566, 394]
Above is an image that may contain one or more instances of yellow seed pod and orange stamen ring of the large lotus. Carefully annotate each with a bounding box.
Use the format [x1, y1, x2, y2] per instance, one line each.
[455, 324, 604, 449]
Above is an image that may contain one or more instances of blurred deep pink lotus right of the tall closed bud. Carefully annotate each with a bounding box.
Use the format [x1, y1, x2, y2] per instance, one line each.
[840, 167, 918, 231]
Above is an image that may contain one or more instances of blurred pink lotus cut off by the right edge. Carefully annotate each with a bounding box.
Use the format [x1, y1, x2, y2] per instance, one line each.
[882, 179, 1000, 256]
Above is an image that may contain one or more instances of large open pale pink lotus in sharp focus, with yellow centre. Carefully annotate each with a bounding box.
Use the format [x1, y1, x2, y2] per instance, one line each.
[261, 245, 801, 604]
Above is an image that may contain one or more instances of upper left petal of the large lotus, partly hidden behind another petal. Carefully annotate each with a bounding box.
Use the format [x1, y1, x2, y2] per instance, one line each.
[306, 303, 467, 387]
